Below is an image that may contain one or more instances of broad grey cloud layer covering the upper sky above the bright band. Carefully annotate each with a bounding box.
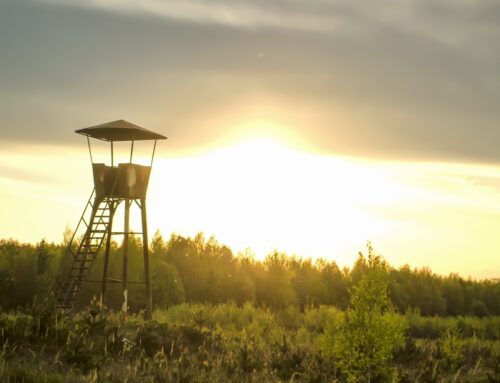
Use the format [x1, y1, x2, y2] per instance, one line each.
[0, 0, 500, 162]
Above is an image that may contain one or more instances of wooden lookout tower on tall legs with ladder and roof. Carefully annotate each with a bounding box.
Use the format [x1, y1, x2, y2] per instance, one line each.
[57, 120, 166, 318]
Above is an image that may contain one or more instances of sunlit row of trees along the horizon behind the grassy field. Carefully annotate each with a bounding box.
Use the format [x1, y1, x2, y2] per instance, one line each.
[0, 232, 500, 317]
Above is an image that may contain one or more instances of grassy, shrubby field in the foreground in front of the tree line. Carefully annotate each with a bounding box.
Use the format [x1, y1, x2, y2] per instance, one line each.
[0, 302, 500, 382]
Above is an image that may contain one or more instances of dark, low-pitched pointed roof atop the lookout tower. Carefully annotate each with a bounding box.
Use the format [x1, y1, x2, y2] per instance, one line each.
[75, 120, 167, 141]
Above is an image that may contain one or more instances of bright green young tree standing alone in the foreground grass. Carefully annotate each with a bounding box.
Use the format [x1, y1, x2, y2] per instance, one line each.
[333, 244, 406, 382]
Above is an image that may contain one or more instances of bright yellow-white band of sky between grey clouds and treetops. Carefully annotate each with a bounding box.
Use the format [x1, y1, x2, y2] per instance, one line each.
[0, 139, 500, 277]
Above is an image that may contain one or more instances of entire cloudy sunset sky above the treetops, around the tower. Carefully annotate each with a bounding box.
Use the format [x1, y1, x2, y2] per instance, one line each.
[0, 0, 500, 278]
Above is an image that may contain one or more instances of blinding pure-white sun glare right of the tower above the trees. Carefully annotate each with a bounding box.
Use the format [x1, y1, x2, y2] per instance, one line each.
[149, 135, 398, 263]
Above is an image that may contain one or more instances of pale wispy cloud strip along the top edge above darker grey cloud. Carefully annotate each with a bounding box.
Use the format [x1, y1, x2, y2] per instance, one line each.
[35, 0, 500, 46]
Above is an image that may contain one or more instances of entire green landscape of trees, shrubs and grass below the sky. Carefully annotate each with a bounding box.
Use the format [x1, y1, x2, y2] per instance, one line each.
[0, 233, 500, 383]
